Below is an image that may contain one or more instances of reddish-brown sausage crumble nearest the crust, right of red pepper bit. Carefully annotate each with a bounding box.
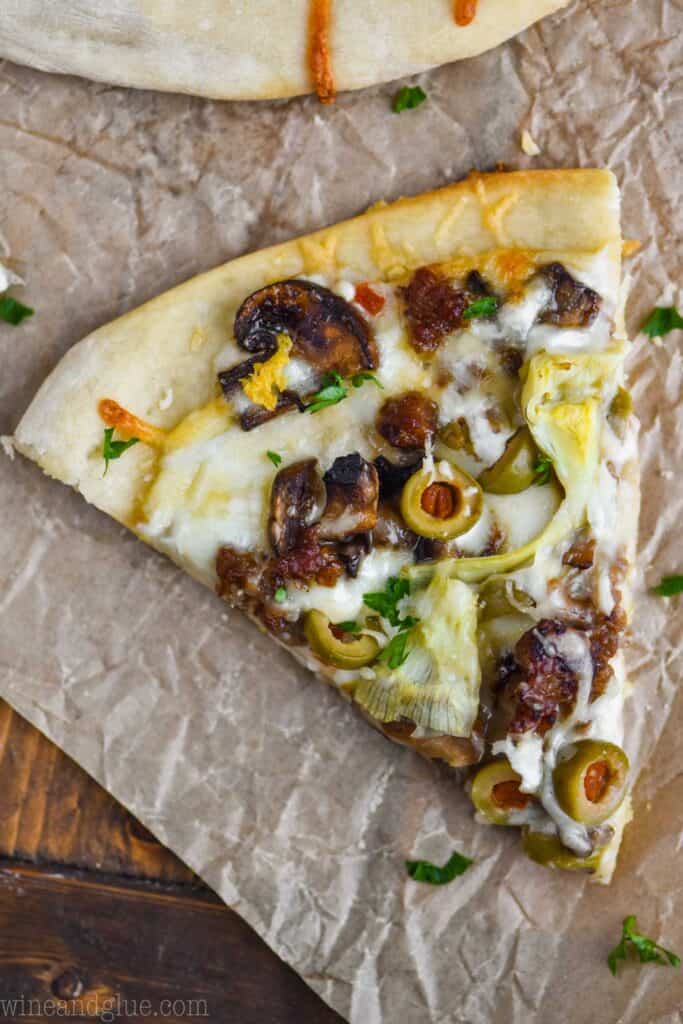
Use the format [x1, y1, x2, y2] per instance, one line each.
[399, 266, 467, 352]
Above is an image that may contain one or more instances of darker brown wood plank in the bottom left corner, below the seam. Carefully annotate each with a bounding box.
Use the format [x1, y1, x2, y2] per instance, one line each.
[0, 860, 341, 1024]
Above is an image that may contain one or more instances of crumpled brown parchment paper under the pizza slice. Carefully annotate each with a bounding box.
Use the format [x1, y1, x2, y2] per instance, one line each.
[0, 0, 683, 1024]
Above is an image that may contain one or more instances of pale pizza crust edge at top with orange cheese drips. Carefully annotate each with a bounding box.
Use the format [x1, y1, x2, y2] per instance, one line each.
[0, 0, 568, 99]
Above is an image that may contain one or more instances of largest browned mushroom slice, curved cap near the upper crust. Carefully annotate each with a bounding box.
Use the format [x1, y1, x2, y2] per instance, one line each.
[234, 281, 378, 377]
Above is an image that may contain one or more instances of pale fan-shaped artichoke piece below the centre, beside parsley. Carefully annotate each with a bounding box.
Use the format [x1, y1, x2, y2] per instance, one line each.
[354, 562, 481, 736]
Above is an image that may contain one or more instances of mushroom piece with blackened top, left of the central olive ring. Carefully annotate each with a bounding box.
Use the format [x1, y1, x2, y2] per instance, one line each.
[318, 452, 380, 541]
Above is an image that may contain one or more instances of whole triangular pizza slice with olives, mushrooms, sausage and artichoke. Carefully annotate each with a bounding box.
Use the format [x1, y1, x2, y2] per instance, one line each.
[15, 170, 638, 881]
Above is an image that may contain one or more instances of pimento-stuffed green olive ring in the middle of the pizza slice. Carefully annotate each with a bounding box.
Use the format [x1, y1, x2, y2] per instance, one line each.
[400, 463, 483, 541]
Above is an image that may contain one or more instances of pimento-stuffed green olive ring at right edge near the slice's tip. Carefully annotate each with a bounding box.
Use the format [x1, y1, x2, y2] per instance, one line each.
[553, 739, 629, 825]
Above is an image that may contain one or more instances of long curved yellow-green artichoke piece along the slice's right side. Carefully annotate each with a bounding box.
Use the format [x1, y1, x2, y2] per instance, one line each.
[403, 352, 606, 583]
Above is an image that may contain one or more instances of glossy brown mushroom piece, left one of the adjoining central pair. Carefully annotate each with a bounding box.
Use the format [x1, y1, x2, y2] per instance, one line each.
[268, 459, 326, 556]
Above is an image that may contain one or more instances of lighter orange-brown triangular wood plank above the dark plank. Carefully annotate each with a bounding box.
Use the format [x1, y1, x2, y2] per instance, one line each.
[0, 701, 195, 884]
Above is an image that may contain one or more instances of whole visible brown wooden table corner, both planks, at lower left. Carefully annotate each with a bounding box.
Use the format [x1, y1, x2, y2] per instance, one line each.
[0, 701, 341, 1024]
